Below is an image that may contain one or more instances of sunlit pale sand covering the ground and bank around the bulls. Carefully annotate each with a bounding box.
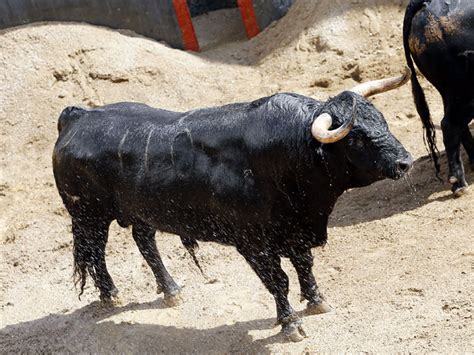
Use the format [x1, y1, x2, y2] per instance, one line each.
[0, 0, 474, 353]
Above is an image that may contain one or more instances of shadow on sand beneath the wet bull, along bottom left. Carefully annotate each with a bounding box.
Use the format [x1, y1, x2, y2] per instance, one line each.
[0, 301, 286, 354]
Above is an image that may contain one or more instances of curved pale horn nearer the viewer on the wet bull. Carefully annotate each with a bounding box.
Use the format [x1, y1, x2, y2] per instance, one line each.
[311, 99, 356, 143]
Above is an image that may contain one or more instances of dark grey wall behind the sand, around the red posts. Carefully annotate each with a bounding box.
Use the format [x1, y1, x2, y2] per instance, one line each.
[0, 0, 294, 49]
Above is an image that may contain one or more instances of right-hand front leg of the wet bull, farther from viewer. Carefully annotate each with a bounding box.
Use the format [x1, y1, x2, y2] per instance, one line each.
[290, 249, 332, 314]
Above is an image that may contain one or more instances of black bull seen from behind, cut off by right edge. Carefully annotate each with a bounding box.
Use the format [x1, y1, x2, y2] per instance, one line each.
[403, 0, 474, 195]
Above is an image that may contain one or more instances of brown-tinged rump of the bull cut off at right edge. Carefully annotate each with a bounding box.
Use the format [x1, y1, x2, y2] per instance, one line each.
[409, 0, 474, 98]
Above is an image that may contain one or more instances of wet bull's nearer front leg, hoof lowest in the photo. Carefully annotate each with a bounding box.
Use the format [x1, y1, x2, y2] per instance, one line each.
[239, 248, 306, 342]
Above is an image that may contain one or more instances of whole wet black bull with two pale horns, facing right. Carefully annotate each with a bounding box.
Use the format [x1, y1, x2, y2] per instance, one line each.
[53, 69, 412, 341]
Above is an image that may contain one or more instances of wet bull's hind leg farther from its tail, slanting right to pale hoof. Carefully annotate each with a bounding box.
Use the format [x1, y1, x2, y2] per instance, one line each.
[132, 224, 181, 307]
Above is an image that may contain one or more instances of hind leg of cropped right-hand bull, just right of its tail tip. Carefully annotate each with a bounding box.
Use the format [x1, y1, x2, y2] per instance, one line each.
[441, 116, 468, 196]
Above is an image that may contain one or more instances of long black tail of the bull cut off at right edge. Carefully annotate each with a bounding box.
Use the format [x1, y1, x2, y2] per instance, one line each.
[403, 0, 440, 178]
